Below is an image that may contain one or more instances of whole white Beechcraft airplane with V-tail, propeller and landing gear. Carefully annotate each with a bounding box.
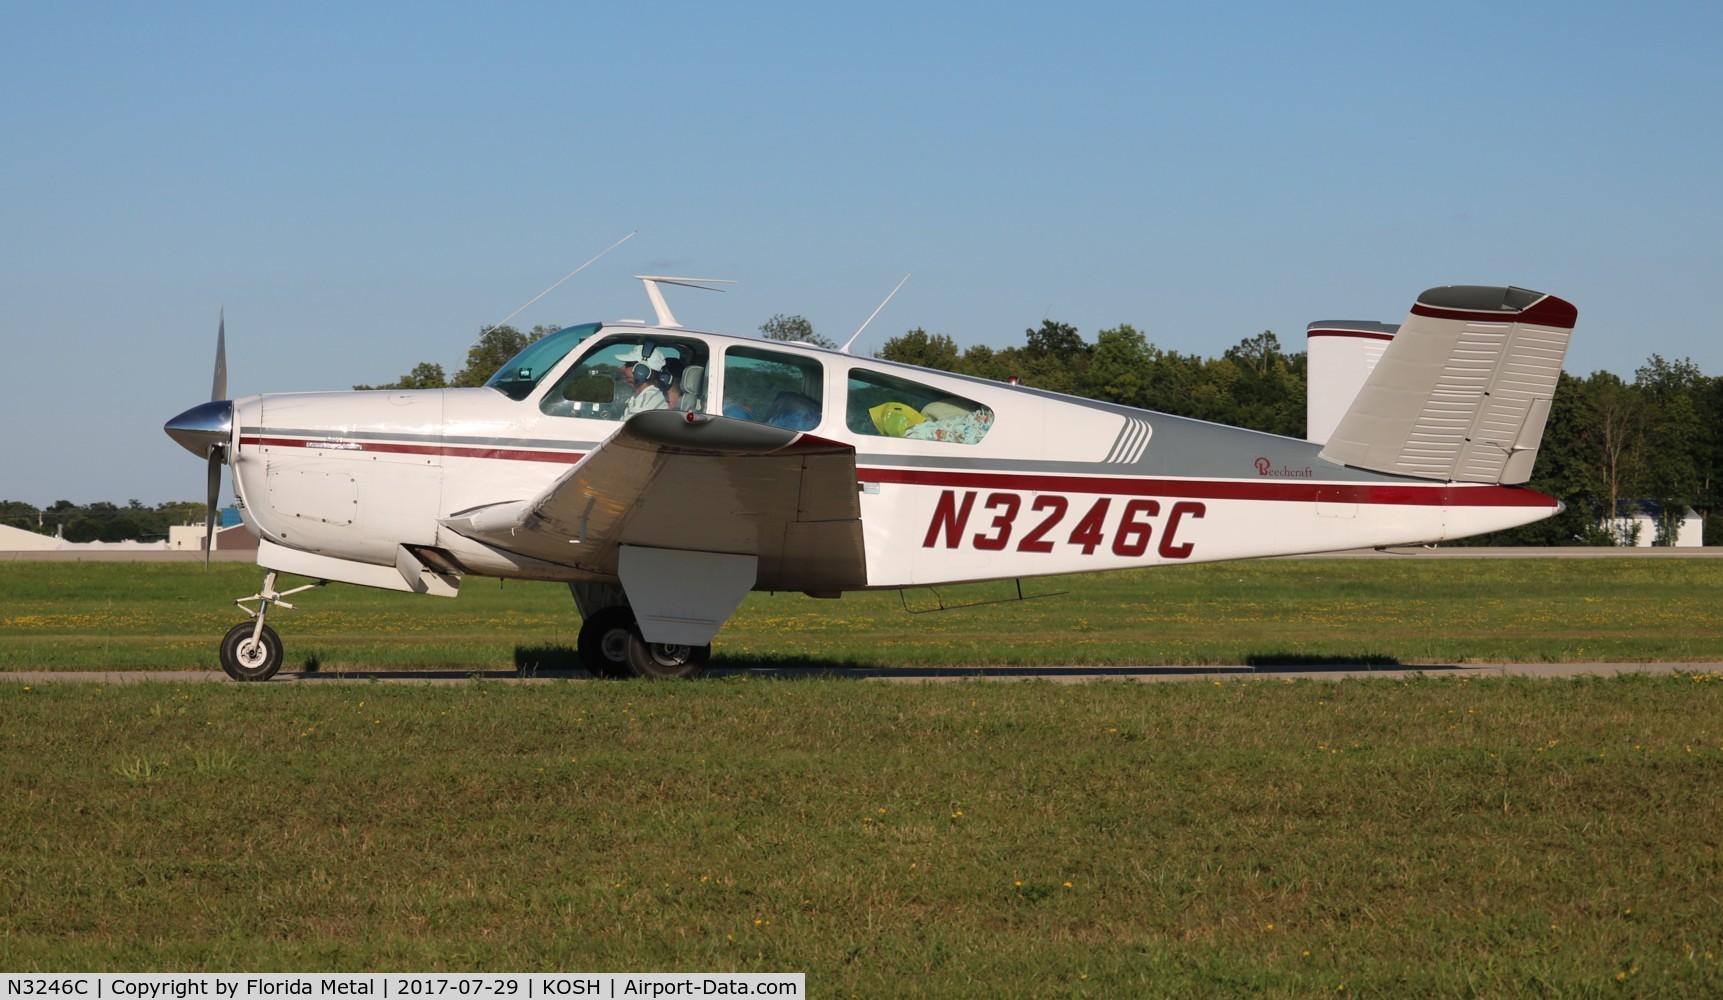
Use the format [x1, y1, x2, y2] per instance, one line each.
[164, 276, 1578, 681]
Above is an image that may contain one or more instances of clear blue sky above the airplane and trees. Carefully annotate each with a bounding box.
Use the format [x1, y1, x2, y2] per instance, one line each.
[0, 0, 1723, 503]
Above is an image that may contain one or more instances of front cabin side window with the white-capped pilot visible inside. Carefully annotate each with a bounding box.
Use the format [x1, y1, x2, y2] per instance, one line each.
[539, 333, 706, 421]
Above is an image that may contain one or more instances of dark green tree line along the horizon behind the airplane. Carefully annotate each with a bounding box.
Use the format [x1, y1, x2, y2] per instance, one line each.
[10, 314, 1723, 545]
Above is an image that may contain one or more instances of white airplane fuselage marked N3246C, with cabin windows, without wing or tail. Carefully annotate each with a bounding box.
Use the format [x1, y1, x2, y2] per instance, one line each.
[215, 322, 1559, 590]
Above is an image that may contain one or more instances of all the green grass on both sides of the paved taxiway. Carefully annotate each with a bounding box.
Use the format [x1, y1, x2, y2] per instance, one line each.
[0, 560, 1723, 997]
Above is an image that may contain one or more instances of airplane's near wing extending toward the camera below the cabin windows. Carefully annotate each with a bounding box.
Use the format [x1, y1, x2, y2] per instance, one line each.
[443, 410, 867, 591]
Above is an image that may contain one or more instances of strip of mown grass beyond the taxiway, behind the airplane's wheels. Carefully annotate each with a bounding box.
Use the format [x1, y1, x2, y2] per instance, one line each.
[0, 559, 1723, 671]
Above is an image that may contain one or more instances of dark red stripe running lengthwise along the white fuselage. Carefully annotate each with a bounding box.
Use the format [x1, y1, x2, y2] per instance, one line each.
[251, 438, 1558, 507]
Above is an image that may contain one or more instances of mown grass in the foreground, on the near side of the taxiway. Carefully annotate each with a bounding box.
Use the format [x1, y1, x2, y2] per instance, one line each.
[0, 674, 1723, 997]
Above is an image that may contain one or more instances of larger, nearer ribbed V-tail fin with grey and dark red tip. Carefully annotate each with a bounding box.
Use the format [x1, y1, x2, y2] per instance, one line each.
[1322, 284, 1578, 483]
